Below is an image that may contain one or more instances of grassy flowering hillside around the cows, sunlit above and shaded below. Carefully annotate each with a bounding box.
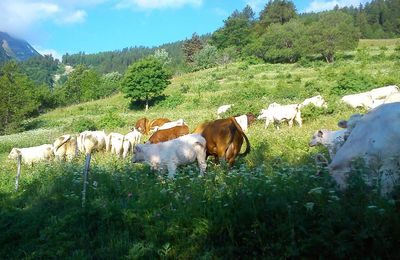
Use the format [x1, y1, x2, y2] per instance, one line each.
[0, 42, 400, 259]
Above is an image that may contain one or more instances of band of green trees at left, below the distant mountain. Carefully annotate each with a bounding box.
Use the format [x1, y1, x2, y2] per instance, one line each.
[0, 60, 122, 135]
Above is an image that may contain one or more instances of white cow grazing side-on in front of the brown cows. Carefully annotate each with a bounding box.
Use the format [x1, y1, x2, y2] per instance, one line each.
[132, 134, 207, 178]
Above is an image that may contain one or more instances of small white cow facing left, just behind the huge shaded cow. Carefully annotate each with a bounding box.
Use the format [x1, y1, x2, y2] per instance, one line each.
[309, 129, 346, 159]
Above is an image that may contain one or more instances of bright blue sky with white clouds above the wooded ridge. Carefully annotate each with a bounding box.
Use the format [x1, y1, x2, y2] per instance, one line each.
[0, 0, 367, 57]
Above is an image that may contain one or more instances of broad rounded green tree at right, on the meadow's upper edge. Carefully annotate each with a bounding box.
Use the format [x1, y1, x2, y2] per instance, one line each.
[307, 11, 359, 63]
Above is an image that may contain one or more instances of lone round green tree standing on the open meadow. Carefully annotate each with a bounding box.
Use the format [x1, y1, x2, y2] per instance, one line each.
[122, 56, 171, 111]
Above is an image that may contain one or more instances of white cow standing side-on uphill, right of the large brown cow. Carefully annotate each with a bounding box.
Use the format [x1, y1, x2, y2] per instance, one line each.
[257, 103, 302, 129]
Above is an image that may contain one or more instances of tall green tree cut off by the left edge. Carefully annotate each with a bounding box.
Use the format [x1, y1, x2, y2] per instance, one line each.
[0, 61, 40, 134]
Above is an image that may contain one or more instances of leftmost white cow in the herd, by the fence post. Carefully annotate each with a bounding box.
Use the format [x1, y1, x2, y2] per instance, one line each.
[8, 144, 54, 165]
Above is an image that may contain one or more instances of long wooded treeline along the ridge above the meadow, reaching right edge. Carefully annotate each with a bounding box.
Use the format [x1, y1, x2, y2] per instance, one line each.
[59, 0, 400, 73]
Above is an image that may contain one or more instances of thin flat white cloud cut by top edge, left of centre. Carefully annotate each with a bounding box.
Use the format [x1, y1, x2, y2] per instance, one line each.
[116, 0, 203, 9]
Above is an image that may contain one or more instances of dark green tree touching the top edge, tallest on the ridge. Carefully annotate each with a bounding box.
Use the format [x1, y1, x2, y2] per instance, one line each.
[260, 0, 297, 27]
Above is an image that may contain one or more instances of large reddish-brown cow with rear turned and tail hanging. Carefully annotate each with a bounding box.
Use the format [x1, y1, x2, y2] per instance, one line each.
[194, 117, 250, 166]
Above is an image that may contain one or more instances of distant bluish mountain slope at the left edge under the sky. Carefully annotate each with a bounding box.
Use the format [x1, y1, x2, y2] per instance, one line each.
[0, 32, 40, 61]
